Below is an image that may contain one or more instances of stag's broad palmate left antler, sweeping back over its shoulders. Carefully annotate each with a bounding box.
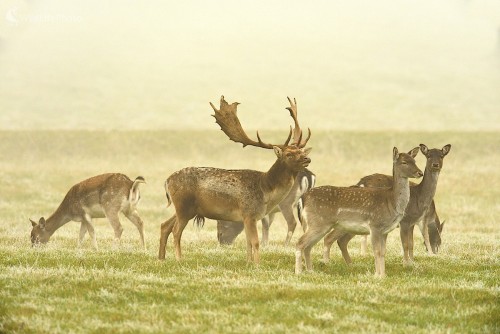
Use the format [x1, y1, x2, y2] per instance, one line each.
[210, 96, 284, 149]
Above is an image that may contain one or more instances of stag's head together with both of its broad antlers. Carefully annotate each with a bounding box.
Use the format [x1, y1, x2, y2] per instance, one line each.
[210, 96, 311, 172]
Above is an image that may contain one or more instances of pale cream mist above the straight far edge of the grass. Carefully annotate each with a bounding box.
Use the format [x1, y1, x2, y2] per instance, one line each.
[0, 0, 500, 131]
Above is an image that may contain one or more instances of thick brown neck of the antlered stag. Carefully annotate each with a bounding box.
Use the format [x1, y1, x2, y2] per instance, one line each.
[260, 159, 298, 202]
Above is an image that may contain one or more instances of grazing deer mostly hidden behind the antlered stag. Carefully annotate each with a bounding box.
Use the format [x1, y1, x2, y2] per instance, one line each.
[217, 168, 316, 246]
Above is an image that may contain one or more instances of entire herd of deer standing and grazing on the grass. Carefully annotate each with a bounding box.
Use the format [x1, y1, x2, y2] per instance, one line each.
[31, 96, 451, 277]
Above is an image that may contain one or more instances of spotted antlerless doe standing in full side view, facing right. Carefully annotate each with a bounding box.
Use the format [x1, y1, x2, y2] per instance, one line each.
[295, 147, 422, 277]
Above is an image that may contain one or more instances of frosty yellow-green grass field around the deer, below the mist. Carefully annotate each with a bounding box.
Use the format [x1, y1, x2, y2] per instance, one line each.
[0, 131, 500, 333]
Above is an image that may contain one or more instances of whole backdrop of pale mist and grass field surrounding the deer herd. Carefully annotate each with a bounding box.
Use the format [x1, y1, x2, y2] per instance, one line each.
[0, 0, 500, 333]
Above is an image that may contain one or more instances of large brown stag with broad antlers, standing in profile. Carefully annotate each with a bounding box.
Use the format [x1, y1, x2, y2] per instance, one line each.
[159, 96, 311, 263]
